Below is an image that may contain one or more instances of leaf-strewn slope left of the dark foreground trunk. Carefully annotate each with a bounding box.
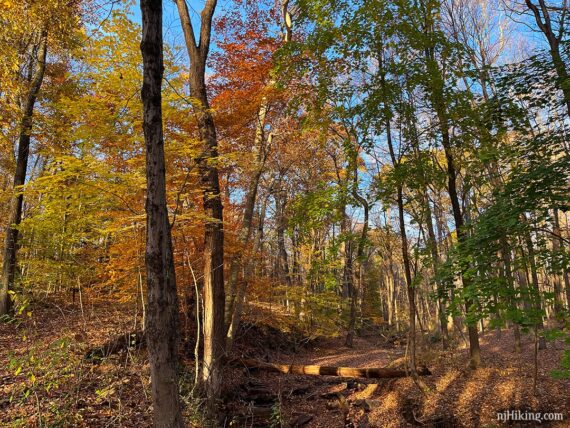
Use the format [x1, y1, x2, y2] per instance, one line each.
[0, 299, 150, 427]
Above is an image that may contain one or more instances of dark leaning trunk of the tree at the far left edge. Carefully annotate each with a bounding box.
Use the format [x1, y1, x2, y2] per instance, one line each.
[0, 30, 47, 316]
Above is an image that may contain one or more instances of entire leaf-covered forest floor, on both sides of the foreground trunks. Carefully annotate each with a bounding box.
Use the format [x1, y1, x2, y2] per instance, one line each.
[0, 300, 570, 428]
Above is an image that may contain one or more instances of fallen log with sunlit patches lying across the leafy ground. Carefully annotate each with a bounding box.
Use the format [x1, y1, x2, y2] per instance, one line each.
[236, 358, 431, 379]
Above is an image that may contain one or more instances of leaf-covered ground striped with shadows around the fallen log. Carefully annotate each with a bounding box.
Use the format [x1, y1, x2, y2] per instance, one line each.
[232, 332, 570, 428]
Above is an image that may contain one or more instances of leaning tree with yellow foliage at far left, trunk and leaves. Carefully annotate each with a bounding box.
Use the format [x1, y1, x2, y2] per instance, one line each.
[0, 0, 88, 315]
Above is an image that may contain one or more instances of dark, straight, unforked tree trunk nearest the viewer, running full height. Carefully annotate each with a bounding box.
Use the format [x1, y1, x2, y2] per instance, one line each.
[141, 0, 184, 428]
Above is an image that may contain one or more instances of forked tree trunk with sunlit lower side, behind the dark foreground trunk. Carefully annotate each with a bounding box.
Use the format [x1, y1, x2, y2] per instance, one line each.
[176, 0, 226, 415]
